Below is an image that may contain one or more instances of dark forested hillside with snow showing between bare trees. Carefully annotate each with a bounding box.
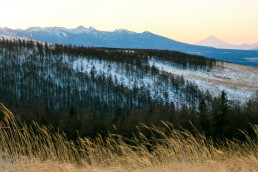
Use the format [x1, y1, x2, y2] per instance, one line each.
[0, 39, 258, 138]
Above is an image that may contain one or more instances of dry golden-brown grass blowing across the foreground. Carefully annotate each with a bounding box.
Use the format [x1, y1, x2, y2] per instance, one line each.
[0, 104, 258, 172]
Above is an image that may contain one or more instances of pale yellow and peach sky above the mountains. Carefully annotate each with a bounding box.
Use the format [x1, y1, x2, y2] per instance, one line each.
[0, 0, 258, 44]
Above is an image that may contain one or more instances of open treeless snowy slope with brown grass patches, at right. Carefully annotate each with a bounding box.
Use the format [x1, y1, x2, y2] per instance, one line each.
[150, 60, 258, 102]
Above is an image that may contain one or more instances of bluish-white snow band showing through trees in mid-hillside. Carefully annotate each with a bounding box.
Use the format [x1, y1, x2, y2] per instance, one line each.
[70, 58, 181, 104]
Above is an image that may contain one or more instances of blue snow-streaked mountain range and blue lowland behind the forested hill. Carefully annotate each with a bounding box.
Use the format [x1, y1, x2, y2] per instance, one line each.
[0, 26, 258, 67]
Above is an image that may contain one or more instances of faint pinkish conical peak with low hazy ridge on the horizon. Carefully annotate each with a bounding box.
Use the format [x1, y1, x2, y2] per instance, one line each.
[196, 36, 258, 50]
